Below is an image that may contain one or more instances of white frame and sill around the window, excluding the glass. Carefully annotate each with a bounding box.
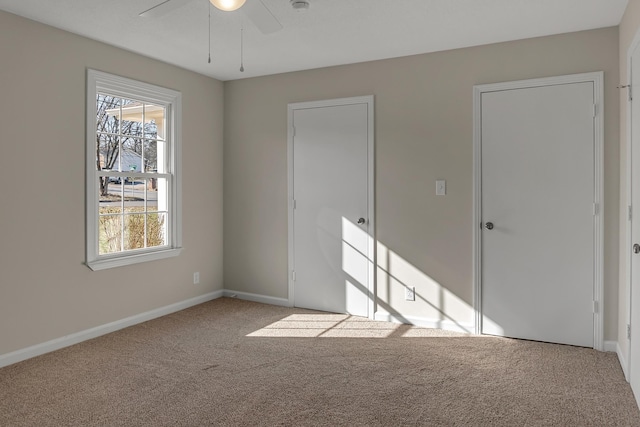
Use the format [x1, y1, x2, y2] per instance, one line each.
[85, 69, 182, 271]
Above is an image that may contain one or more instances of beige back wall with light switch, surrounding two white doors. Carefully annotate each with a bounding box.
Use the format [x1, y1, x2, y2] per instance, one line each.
[224, 28, 619, 340]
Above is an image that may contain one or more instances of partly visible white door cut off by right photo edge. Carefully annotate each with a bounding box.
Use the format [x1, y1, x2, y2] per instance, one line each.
[625, 44, 640, 405]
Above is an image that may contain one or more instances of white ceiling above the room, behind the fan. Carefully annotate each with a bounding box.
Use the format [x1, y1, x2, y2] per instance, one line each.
[0, 0, 628, 80]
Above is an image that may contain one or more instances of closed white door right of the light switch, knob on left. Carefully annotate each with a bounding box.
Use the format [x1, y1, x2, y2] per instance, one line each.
[481, 82, 595, 347]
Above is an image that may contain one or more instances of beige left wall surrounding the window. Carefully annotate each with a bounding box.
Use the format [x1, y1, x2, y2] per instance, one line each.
[0, 12, 224, 355]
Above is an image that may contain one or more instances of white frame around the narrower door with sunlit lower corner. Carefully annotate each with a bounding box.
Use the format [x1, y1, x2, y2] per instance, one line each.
[287, 95, 377, 319]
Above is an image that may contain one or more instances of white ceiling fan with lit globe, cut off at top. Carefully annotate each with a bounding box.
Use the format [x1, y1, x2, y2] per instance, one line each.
[140, 0, 282, 34]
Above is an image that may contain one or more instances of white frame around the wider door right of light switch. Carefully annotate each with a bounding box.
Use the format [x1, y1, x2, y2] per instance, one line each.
[472, 72, 604, 351]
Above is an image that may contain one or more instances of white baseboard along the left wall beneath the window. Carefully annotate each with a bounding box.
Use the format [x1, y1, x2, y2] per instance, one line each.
[0, 291, 223, 368]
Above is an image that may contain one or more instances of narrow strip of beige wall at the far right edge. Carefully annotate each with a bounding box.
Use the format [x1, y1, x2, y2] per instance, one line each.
[617, 0, 640, 366]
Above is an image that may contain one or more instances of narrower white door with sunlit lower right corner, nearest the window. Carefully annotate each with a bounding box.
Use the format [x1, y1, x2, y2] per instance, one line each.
[289, 97, 373, 316]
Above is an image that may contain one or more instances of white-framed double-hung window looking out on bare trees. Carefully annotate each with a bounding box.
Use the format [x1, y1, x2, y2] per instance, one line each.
[86, 70, 181, 270]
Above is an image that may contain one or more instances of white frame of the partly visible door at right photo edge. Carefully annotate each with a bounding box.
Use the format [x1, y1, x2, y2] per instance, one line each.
[617, 30, 640, 381]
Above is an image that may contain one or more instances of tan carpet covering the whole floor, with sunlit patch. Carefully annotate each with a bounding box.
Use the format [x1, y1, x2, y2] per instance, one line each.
[0, 298, 640, 426]
